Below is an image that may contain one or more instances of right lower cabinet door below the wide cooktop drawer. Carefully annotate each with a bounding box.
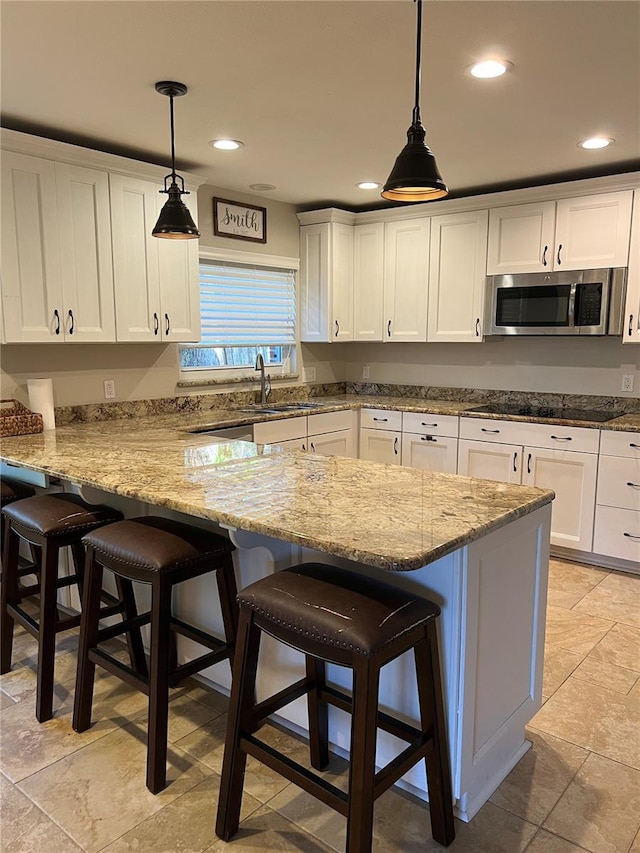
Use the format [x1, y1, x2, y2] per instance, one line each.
[522, 447, 598, 551]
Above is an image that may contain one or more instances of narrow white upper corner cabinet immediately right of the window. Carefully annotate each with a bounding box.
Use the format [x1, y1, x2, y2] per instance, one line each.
[300, 222, 353, 343]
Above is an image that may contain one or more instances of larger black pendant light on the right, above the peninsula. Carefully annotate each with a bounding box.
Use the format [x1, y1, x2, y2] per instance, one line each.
[382, 0, 449, 201]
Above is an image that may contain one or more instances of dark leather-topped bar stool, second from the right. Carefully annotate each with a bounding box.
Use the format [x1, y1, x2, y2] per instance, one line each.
[73, 517, 237, 794]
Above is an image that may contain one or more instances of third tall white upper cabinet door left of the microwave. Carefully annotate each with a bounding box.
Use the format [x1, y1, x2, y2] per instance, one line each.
[353, 222, 384, 341]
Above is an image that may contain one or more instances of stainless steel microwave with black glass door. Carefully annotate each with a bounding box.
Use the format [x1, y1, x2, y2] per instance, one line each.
[485, 267, 627, 335]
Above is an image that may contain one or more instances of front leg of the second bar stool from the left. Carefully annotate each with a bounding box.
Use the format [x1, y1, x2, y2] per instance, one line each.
[36, 540, 60, 723]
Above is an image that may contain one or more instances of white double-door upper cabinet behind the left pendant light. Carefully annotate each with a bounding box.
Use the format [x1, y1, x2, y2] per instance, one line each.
[109, 175, 200, 342]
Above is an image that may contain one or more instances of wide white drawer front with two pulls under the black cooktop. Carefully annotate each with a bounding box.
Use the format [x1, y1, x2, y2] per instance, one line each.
[460, 417, 600, 453]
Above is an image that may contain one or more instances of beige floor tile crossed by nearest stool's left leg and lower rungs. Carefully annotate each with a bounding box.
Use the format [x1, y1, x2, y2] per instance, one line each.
[177, 714, 309, 803]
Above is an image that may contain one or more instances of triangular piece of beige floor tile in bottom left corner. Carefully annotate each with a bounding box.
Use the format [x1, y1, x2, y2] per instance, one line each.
[0, 775, 81, 853]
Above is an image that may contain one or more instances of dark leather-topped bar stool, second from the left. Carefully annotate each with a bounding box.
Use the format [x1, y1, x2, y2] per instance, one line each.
[0, 494, 132, 723]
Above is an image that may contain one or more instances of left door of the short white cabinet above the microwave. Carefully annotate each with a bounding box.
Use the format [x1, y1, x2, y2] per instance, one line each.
[487, 201, 556, 275]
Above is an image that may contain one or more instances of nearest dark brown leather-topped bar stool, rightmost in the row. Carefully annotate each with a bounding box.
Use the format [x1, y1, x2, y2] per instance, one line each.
[216, 563, 455, 853]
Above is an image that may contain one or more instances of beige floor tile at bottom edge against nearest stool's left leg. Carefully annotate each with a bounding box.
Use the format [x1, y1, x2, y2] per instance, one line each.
[102, 773, 261, 853]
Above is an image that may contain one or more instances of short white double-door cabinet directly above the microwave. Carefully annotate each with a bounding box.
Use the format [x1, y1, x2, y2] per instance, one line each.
[487, 190, 633, 275]
